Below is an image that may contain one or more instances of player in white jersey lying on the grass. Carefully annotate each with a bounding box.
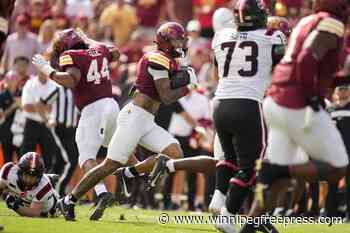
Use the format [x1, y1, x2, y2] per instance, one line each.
[0, 152, 59, 217]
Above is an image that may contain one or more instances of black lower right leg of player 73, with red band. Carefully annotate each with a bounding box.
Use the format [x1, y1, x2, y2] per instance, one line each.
[226, 170, 255, 214]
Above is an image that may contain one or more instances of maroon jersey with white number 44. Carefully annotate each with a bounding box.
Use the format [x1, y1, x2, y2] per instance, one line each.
[59, 45, 112, 110]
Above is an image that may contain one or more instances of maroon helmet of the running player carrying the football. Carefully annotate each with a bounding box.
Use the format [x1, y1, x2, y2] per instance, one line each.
[154, 22, 188, 58]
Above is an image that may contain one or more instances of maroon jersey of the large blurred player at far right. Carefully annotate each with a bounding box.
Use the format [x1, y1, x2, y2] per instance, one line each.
[268, 12, 344, 109]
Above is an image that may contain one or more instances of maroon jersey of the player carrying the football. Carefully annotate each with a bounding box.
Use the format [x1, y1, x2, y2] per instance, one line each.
[135, 51, 179, 102]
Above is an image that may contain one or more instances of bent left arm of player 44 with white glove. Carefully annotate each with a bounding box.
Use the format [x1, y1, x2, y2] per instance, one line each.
[32, 54, 81, 88]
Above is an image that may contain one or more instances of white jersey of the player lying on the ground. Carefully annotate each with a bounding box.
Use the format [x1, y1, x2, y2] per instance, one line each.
[0, 163, 59, 213]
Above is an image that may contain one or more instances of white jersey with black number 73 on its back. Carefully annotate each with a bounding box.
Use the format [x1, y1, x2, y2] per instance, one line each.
[212, 28, 287, 102]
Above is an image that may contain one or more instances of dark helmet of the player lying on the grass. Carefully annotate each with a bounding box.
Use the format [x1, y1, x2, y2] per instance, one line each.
[17, 152, 45, 191]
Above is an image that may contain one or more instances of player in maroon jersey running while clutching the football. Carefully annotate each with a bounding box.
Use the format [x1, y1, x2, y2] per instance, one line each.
[53, 22, 196, 220]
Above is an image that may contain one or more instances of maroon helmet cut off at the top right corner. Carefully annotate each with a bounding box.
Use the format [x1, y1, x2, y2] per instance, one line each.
[314, 0, 350, 23]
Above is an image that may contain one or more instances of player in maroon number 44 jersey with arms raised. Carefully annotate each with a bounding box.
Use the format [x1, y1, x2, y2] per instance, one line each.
[33, 29, 119, 220]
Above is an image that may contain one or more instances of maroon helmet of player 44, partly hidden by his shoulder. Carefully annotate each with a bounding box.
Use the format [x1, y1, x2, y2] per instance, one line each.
[49, 29, 89, 68]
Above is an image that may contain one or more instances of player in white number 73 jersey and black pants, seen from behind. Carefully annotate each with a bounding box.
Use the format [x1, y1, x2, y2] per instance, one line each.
[212, 0, 286, 232]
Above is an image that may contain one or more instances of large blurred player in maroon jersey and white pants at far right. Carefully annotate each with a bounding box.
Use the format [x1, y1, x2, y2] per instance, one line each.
[241, 0, 350, 233]
